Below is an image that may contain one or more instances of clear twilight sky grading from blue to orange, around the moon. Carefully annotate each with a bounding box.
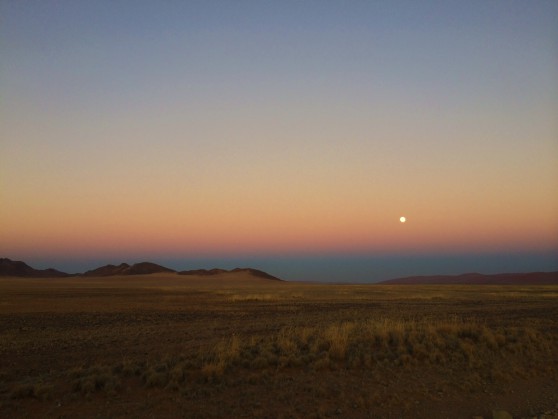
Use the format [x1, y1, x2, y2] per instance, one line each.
[0, 0, 558, 282]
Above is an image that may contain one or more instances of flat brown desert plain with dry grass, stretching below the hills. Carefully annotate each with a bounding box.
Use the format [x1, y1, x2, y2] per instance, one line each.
[0, 274, 558, 418]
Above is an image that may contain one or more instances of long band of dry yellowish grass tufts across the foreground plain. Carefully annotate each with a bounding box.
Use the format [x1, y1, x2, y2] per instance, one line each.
[16, 318, 555, 398]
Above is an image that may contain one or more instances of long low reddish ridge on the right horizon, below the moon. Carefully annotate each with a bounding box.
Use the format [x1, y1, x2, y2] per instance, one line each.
[378, 272, 558, 285]
